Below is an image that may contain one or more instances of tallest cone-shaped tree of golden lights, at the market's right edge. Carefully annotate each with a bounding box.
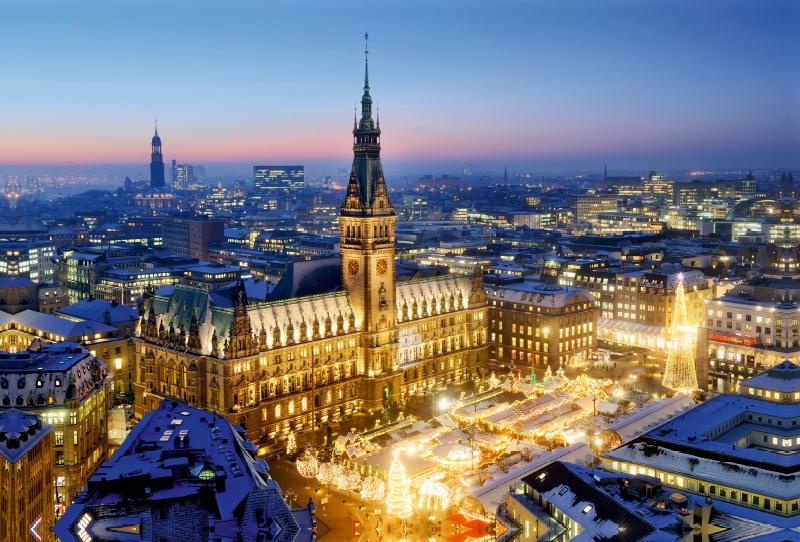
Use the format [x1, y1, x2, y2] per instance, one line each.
[663, 274, 697, 393]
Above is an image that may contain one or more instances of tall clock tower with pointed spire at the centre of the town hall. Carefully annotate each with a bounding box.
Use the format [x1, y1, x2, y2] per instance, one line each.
[339, 35, 397, 401]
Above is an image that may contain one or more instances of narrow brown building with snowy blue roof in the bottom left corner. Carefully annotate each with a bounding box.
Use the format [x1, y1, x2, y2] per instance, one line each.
[0, 408, 54, 542]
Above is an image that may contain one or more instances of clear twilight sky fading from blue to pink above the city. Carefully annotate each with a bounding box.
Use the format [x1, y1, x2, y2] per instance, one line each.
[0, 0, 800, 173]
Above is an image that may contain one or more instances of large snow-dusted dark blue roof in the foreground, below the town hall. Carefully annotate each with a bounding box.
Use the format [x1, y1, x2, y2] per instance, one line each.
[53, 401, 301, 542]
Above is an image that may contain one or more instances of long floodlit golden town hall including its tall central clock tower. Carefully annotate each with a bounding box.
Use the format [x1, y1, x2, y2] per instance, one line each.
[134, 46, 487, 444]
